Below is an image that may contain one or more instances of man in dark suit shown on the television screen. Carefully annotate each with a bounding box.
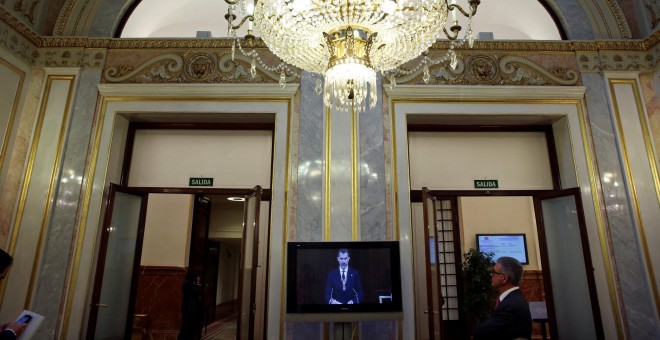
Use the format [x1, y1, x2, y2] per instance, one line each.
[325, 249, 363, 305]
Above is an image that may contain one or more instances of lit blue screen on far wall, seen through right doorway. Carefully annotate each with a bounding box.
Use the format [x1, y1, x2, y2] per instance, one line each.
[477, 234, 529, 264]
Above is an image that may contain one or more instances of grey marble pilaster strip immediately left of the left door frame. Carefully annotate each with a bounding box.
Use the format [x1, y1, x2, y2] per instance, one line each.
[31, 69, 101, 339]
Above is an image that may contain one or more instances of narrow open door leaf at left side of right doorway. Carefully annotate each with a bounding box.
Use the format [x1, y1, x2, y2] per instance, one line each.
[422, 188, 443, 339]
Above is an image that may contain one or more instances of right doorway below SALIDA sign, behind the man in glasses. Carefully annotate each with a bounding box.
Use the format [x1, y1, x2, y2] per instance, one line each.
[411, 189, 603, 339]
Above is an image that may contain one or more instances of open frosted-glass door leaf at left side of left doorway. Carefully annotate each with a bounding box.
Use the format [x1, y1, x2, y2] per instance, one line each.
[87, 184, 147, 339]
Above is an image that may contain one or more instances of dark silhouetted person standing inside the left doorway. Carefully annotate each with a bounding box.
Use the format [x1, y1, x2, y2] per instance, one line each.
[177, 270, 203, 340]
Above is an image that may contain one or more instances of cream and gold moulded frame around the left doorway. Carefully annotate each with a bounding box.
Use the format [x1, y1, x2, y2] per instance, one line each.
[78, 83, 300, 338]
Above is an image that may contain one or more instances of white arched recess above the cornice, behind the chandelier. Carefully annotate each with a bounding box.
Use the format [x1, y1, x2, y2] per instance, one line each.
[121, 0, 561, 40]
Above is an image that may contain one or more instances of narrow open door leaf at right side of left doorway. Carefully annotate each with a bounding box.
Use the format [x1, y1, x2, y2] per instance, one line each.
[237, 186, 261, 340]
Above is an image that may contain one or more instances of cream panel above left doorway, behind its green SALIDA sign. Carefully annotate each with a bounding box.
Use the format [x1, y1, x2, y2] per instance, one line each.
[128, 130, 273, 188]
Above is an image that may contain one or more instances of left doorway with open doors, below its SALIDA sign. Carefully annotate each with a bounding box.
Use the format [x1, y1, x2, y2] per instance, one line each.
[88, 185, 270, 339]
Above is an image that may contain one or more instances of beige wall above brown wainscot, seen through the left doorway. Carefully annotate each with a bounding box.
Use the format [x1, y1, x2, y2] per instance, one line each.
[140, 194, 195, 267]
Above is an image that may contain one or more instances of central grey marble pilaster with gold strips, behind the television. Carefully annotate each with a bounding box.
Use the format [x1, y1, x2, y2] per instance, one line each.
[292, 72, 397, 339]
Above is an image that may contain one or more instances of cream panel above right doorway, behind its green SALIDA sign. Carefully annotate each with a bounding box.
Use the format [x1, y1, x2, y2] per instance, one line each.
[408, 132, 552, 190]
